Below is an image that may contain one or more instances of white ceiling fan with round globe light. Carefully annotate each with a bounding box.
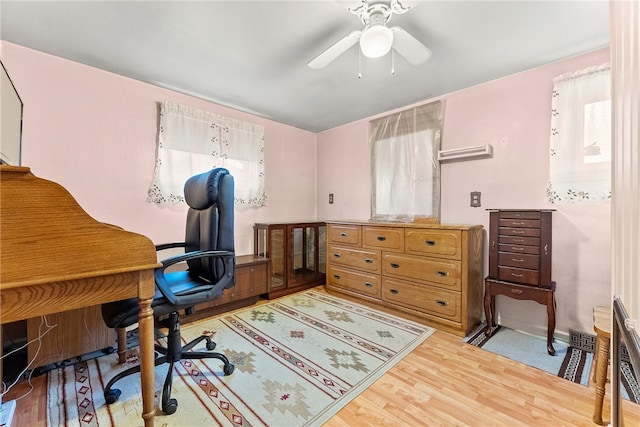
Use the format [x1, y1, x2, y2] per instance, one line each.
[307, 0, 431, 69]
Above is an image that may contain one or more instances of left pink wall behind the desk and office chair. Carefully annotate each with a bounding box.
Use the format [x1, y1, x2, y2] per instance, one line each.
[1, 41, 316, 255]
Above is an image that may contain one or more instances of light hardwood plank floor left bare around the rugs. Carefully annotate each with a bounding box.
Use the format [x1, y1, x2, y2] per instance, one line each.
[4, 288, 640, 427]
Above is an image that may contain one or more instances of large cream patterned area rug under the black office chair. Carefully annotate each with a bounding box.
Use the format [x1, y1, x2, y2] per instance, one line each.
[47, 290, 434, 427]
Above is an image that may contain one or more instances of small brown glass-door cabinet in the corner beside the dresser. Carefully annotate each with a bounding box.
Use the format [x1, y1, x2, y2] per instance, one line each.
[254, 222, 326, 298]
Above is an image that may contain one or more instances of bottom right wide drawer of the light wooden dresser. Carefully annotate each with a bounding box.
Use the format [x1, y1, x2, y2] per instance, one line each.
[382, 278, 461, 322]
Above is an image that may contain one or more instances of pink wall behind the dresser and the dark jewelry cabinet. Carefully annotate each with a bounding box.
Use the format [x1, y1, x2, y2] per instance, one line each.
[318, 49, 611, 335]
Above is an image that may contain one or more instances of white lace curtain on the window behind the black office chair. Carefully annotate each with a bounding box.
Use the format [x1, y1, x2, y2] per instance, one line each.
[147, 101, 266, 207]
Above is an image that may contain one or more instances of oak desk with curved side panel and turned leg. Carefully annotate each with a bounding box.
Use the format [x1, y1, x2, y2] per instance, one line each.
[0, 165, 158, 427]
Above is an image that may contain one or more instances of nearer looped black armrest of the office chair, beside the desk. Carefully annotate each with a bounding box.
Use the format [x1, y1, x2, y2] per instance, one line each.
[154, 251, 235, 306]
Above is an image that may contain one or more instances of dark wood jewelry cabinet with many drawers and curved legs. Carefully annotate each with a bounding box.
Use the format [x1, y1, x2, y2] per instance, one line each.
[484, 209, 556, 355]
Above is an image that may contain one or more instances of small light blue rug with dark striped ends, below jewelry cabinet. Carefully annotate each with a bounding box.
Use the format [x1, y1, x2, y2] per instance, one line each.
[466, 324, 640, 403]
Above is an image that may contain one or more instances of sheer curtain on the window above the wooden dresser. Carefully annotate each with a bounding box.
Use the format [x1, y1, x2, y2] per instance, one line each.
[369, 101, 442, 222]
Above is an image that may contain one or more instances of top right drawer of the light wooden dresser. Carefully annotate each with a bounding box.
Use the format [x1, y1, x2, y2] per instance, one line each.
[404, 229, 462, 259]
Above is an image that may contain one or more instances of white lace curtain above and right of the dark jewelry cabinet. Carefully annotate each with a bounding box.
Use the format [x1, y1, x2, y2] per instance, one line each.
[547, 64, 612, 204]
